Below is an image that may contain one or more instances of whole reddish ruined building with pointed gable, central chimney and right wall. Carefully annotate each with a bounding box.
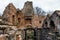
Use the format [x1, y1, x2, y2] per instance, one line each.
[2, 1, 46, 29]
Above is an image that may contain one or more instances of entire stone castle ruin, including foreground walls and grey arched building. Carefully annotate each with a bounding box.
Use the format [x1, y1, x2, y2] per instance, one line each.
[0, 1, 60, 40]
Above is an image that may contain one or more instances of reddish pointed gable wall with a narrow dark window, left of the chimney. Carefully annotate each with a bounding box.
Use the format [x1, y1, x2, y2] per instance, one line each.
[2, 3, 16, 25]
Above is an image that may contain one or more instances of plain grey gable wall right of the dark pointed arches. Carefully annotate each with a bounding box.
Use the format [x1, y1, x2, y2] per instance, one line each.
[51, 10, 60, 32]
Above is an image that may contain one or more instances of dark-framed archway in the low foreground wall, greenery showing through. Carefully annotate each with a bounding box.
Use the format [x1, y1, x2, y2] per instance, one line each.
[25, 25, 35, 40]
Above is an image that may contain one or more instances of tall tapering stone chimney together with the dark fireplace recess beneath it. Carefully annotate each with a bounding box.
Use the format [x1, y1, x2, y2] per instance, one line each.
[22, 1, 34, 26]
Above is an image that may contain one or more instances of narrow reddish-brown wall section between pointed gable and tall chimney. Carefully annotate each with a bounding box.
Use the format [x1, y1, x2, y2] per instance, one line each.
[16, 10, 25, 28]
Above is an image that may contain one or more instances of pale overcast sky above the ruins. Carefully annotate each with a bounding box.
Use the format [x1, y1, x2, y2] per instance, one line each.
[0, 0, 60, 13]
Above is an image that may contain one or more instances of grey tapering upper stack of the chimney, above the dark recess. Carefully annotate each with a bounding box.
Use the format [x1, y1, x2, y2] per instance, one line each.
[22, 1, 34, 16]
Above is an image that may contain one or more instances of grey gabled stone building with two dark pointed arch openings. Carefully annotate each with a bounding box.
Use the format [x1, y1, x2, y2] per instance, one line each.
[42, 11, 60, 32]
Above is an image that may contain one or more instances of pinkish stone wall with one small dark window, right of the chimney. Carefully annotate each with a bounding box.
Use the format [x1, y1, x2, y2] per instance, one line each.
[32, 15, 45, 28]
